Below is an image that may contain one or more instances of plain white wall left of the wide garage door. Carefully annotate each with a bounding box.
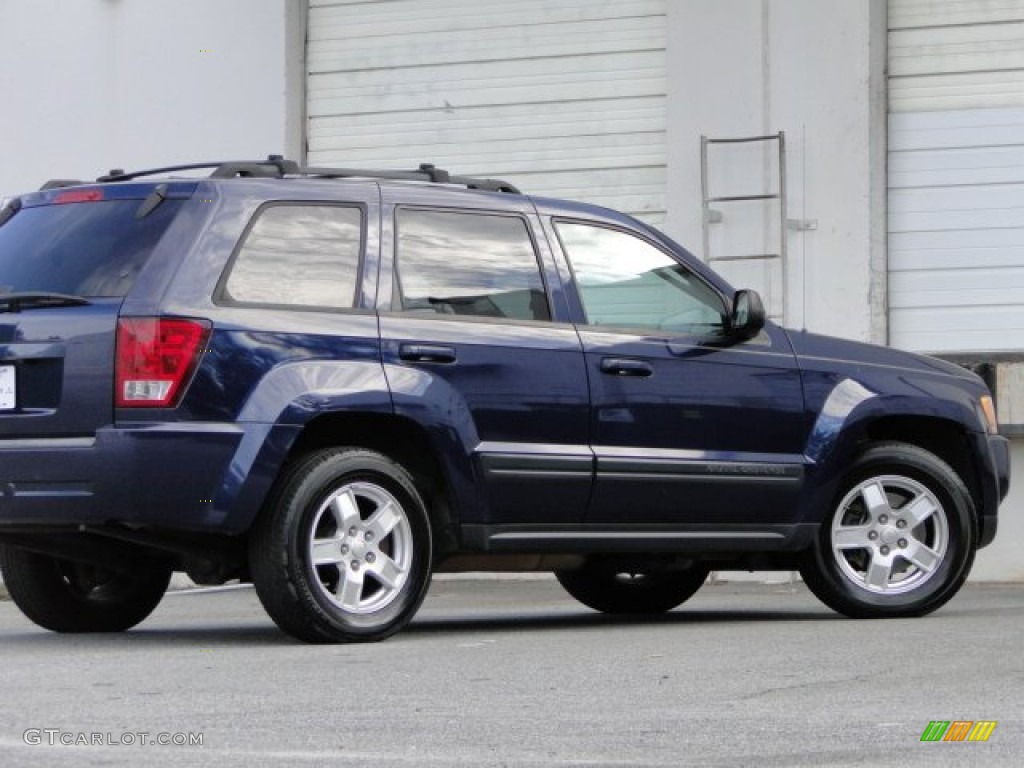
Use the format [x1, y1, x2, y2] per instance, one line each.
[0, 0, 304, 198]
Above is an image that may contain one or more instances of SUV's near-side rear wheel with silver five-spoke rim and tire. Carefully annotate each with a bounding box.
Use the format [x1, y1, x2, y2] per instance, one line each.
[249, 449, 432, 643]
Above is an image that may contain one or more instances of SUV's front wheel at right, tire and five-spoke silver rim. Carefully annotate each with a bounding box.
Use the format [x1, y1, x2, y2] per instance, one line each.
[800, 442, 978, 618]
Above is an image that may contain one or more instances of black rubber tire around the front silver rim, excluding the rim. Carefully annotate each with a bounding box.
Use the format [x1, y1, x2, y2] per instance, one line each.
[808, 446, 977, 615]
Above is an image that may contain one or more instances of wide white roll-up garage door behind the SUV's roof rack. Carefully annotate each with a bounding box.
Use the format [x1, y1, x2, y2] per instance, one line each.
[306, 0, 666, 223]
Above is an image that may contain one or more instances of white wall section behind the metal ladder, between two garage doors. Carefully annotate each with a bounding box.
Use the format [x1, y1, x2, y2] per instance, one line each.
[666, 0, 886, 342]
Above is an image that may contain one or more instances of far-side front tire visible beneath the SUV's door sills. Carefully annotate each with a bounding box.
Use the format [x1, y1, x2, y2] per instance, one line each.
[555, 560, 710, 613]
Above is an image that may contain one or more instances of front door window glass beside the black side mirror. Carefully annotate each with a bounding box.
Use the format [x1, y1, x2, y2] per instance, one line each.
[555, 221, 726, 334]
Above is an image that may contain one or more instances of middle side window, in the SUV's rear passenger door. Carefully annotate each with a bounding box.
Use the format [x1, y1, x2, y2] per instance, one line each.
[397, 209, 551, 321]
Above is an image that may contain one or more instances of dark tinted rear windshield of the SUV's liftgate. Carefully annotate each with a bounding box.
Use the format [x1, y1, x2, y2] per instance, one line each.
[0, 199, 183, 297]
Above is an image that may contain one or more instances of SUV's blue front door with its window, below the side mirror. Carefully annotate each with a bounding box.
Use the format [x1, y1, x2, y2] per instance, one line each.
[553, 219, 808, 529]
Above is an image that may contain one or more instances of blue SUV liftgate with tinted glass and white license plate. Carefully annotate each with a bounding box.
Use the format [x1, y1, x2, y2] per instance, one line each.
[0, 184, 188, 439]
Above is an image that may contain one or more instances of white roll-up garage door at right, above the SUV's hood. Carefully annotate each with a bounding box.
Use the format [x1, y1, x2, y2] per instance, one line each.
[889, 0, 1024, 352]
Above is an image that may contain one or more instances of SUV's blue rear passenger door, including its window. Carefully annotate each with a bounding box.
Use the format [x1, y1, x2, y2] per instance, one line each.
[380, 187, 593, 525]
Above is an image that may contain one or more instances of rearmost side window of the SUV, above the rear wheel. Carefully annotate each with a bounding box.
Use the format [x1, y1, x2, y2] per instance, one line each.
[224, 205, 362, 308]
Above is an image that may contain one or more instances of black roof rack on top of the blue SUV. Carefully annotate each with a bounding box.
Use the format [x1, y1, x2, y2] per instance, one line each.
[78, 155, 520, 195]
